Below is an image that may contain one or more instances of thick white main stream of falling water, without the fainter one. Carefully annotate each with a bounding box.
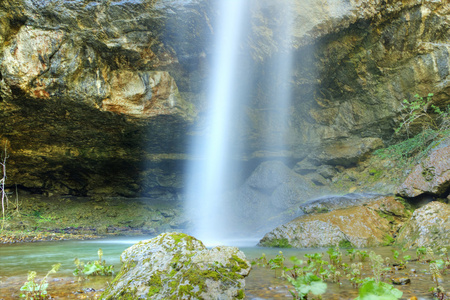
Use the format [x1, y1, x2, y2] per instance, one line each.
[188, 0, 247, 244]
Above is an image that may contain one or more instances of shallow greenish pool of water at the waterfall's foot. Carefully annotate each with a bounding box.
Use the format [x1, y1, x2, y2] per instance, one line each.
[0, 237, 442, 300]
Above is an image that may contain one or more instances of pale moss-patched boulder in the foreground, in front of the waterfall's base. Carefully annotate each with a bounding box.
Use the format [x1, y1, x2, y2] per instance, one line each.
[101, 233, 251, 300]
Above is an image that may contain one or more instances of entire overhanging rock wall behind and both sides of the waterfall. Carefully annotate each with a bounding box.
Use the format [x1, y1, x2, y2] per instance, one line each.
[0, 0, 450, 200]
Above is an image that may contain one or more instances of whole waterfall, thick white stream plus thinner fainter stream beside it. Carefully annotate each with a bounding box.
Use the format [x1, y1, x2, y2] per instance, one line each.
[186, 0, 292, 245]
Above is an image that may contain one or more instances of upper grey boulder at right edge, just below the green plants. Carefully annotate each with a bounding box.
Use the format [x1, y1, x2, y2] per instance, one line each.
[398, 138, 450, 197]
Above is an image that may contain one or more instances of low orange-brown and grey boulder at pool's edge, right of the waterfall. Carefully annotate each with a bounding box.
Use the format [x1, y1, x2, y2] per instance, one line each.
[259, 197, 406, 248]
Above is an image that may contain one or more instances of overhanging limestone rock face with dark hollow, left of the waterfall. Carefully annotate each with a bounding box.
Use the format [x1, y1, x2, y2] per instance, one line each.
[0, 0, 203, 196]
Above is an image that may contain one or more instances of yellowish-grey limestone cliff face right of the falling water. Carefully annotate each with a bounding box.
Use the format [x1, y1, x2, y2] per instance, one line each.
[249, 0, 450, 166]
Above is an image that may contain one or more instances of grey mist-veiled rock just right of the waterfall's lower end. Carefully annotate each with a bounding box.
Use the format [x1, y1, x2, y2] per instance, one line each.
[227, 161, 326, 235]
